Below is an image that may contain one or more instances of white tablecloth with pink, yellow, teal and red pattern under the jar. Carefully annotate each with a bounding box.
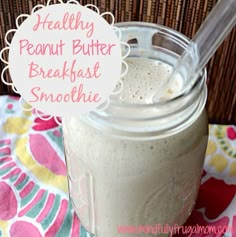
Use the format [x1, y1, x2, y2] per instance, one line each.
[0, 96, 236, 237]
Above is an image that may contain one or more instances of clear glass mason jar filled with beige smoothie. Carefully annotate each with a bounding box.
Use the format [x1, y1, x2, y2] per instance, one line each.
[62, 22, 208, 237]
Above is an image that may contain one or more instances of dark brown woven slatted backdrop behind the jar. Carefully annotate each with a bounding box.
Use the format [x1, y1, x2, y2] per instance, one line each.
[0, 0, 236, 124]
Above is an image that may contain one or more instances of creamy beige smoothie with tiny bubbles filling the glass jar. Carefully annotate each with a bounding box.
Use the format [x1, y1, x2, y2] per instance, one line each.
[63, 57, 207, 237]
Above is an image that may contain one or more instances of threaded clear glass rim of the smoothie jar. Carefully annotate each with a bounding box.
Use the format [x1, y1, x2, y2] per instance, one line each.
[84, 22, 207, 140]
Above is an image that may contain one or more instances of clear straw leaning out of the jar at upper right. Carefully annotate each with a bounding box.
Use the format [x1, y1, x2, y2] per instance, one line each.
[154, 0, 236, 100]
